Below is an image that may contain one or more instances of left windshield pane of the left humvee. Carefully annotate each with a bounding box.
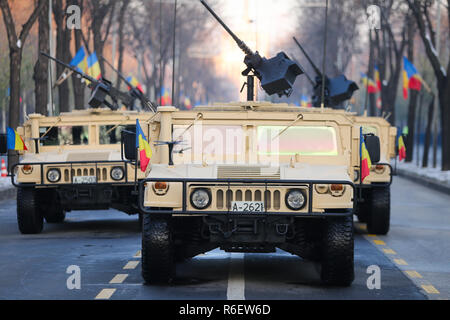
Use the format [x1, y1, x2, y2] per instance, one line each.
[39, 126, 89, 146]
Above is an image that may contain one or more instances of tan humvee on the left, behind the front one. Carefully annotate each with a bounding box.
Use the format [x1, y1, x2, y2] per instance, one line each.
[3, 109, 152, 234]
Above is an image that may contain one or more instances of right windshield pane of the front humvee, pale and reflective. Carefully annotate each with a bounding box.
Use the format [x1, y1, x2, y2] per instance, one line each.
[257, 126, 338, 156]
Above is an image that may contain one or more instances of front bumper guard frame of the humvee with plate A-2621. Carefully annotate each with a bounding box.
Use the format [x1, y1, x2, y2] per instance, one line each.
[138, 178, 355, 218]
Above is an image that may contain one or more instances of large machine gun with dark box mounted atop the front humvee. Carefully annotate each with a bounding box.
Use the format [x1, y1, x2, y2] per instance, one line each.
[200, 0, 303, 101]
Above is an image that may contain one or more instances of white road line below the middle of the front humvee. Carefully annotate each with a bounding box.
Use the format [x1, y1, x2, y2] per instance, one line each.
[227, 253, 245, 300]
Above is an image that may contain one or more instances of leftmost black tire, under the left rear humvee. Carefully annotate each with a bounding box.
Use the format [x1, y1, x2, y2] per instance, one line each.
[17, 187, 44, 234]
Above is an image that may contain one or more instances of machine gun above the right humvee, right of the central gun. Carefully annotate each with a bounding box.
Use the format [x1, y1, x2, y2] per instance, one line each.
[294, 37, 359, 108]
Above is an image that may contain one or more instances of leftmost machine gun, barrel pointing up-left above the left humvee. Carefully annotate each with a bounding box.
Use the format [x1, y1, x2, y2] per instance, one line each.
[41, 52, 134, 110]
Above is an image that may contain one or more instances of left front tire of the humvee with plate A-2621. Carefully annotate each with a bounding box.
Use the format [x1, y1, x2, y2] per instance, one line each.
[142, 214, 175, 284]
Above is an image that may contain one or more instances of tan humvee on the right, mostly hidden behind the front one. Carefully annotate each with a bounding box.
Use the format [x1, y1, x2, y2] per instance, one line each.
[353, 116, 397, 234]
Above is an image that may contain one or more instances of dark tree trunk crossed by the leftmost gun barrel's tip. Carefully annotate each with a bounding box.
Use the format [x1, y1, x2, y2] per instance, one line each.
[33, 1, 49, 116]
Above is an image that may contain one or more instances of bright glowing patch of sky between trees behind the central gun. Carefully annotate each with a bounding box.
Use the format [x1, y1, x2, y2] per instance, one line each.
[207, 0, 297, 99]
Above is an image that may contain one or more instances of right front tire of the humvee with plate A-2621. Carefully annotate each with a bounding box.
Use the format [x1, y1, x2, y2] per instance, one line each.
[321, 216, 355, 286]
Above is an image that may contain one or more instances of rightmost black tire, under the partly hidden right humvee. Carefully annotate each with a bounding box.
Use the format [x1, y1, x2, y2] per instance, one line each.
[367, 187, 391, 235]
